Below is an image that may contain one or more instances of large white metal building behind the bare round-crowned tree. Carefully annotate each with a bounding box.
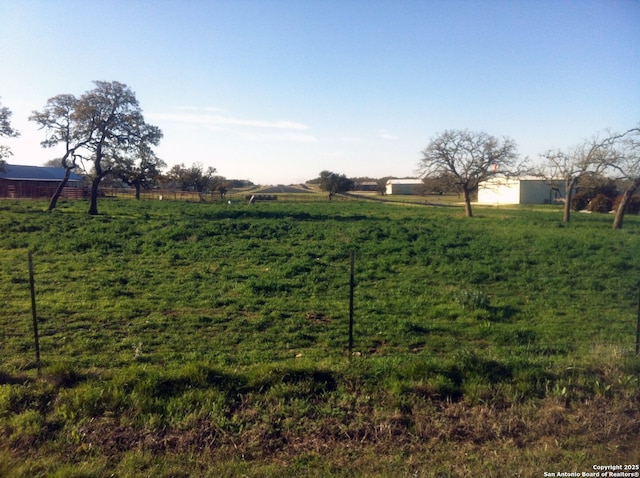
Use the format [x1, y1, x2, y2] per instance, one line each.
[478, 176, 565, 205]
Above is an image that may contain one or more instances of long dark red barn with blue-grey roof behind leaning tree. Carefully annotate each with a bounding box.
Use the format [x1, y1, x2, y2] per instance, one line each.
[0, 164, 83, 199]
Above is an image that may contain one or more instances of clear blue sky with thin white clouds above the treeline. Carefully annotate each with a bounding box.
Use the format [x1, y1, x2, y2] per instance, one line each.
[0, 0, 640, 184]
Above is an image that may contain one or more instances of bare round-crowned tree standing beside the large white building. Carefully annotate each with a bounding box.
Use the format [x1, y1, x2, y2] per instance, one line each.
[418, 130, 518, 217]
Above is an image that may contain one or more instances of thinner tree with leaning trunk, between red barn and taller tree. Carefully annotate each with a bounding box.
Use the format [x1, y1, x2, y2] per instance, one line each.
[29, 95, 91, 211]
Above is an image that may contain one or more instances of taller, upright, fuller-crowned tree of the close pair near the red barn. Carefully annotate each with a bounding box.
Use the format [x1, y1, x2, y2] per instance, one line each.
[74, 81, 162, 215]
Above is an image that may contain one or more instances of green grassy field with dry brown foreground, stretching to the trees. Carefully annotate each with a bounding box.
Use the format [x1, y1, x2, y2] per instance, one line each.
[0, 198, 640, 477]
